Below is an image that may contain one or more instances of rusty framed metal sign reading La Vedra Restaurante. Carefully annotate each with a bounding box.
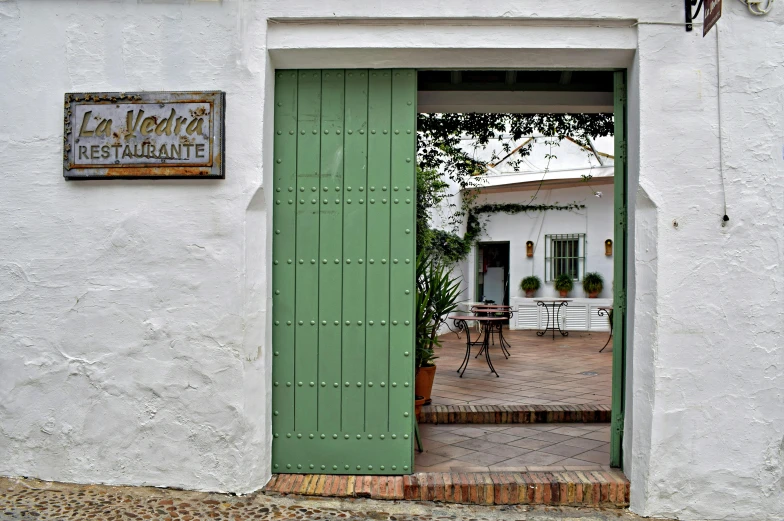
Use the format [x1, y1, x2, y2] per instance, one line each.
[63, 92, 225, 179]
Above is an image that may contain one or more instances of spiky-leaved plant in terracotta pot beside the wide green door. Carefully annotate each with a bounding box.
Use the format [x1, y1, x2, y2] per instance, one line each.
[414, 253, 460, 404]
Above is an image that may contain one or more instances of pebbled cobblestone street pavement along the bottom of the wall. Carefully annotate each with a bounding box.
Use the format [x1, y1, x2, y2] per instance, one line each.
[0, 478, 660, 521]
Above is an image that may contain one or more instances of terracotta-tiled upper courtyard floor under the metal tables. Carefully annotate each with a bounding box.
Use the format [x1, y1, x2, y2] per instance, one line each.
[432, 329, 612, 405]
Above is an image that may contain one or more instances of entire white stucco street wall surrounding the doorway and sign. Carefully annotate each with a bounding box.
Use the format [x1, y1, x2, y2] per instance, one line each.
[0, 0, 784, 520]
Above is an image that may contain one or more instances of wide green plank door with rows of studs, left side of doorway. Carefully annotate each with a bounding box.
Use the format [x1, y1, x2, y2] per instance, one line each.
[272, 69, 416, 474]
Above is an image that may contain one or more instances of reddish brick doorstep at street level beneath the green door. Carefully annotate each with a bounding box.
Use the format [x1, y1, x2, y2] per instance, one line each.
[263, 470, 629, 508]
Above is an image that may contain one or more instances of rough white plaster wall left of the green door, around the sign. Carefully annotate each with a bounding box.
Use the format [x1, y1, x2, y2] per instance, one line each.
[0, 2, 270, 492]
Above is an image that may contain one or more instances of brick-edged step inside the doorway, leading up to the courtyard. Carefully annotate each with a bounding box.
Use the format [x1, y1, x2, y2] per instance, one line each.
[417, 405, 610, 424]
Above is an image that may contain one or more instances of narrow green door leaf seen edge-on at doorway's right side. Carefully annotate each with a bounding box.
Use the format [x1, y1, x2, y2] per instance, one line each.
[610, 71, 628, 467]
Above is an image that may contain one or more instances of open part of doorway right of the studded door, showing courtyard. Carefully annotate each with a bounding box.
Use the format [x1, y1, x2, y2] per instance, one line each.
[416, 70, 626, 472]
